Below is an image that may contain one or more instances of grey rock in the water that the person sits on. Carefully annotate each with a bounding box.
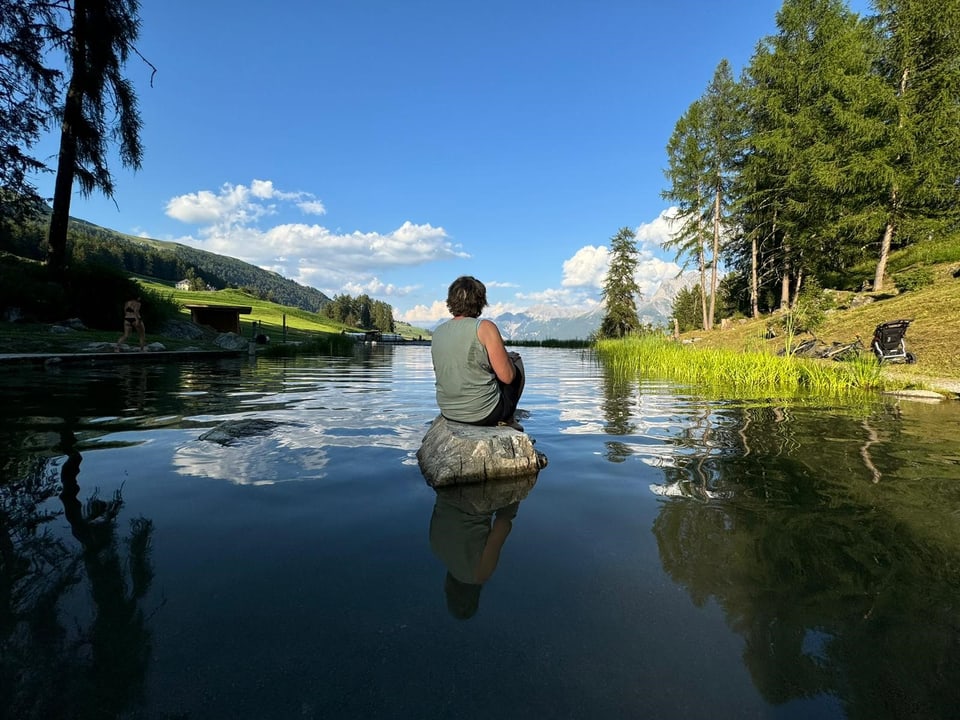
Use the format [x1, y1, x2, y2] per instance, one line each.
[417, 415, 547, 487]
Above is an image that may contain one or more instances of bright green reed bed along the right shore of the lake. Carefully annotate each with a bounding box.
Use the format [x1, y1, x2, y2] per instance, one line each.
[595, 335, 887, 396]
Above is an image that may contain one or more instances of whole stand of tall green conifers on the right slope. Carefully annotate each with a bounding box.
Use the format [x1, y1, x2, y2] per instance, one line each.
[663, 0, 960, 318]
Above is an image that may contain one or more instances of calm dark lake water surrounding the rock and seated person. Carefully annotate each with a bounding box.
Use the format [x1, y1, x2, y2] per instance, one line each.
[0, 346, 960, 720]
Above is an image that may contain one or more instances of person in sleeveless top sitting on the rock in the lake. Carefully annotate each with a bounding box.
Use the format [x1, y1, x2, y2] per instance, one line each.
[430, 276, 524, 430]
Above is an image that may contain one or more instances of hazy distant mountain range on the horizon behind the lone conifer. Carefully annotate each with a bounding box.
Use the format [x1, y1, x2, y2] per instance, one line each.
[491, 274, 697, 340]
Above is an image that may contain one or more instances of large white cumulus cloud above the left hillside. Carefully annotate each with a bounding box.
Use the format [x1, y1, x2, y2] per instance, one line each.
[166, 180, 469, 295]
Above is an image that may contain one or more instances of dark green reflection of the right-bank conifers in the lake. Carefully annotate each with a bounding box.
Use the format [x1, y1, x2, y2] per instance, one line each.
[653, 408, 960, 719]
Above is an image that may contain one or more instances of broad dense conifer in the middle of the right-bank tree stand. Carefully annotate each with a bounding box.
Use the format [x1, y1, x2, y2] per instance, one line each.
[739, 0, 883, 308]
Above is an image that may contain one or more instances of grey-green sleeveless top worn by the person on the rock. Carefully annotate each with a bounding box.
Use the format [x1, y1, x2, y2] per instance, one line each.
[430, 318, 500, 422]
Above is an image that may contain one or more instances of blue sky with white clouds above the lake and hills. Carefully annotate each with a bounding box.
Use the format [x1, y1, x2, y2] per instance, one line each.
[30, 0, 872, 324]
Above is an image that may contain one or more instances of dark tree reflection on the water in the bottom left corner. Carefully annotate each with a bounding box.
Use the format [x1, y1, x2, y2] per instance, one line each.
[0, 433, 153, 719]
